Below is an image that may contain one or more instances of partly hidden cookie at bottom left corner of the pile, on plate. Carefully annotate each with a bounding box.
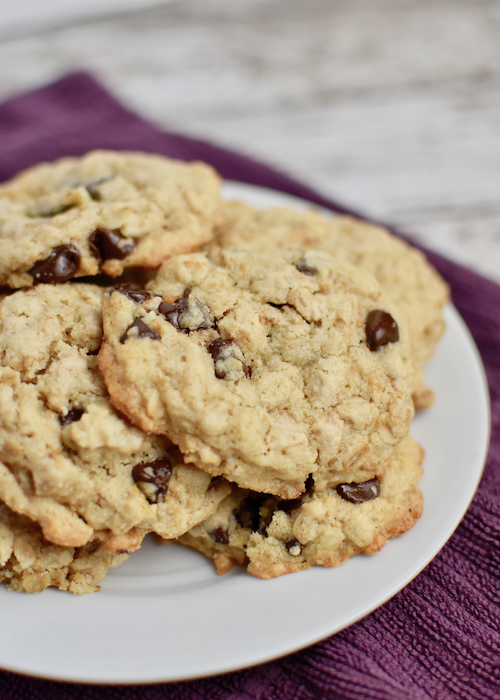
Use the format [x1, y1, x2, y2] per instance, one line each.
[0, 502, 128, 594]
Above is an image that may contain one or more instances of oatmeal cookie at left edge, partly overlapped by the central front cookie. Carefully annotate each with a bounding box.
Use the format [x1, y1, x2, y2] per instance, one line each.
[0, 283, 229, 551]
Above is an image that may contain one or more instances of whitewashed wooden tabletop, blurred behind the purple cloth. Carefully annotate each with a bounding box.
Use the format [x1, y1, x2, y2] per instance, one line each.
[0, 0, 500, 282]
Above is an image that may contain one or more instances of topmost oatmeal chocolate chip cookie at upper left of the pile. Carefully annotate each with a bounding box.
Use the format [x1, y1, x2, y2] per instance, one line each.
[0, 151, 221, 288]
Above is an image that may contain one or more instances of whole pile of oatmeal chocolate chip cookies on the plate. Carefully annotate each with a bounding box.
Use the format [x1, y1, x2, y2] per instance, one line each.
[0, 151, 448, 593]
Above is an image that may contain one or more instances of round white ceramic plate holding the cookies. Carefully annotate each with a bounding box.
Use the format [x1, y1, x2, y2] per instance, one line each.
[0, 183, 489, 683]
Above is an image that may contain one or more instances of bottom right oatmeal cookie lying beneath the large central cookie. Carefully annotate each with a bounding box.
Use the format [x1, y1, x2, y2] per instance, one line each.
[178, 436, 423, 578]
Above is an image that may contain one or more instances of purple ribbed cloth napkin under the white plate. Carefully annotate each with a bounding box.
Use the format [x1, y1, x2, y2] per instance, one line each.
[0, 73, 500, 700]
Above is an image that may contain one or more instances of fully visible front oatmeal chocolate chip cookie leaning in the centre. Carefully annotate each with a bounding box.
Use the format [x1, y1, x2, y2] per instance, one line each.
[99, 250, 413, 498]
